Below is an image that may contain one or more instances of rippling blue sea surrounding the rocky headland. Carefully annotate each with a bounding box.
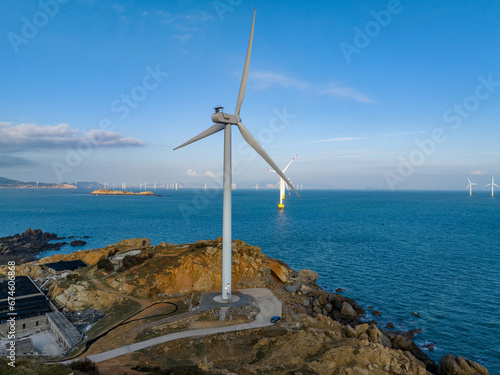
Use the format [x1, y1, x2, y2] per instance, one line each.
[0, 189, 500, 374]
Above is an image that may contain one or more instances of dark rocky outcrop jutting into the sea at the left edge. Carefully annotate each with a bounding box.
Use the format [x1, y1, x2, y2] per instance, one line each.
[0, 228, 88, 264]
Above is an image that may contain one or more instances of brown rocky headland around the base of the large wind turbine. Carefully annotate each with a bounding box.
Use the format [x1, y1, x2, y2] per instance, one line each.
[0, 239, 488, 375]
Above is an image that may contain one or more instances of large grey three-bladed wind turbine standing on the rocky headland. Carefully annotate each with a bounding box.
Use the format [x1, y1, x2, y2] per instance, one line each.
[174, 10, 300, 303]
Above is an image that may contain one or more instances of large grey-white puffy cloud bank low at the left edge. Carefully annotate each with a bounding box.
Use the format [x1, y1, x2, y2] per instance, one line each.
[0, 123, 144, 152]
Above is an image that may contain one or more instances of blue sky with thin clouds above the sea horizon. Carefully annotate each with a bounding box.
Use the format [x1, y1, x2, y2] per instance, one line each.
[0, 0, 500, 191]
